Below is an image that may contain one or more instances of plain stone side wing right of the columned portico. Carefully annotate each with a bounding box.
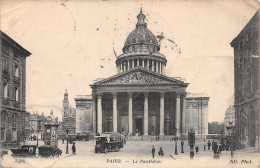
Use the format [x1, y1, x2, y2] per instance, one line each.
[183, 94, 209, 139]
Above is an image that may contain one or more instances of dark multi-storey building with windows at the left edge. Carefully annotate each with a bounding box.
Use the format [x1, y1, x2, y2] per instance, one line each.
[0, 31, 31, 146]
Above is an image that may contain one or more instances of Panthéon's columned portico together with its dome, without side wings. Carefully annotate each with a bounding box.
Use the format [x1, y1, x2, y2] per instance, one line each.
[90, 10, 188, 136]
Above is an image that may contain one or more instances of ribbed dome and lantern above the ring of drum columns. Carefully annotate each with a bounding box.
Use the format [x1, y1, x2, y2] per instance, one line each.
[123, 10, 160, 53]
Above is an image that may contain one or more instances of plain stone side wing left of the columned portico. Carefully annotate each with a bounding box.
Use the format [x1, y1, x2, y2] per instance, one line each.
[75, 95, 95, 134]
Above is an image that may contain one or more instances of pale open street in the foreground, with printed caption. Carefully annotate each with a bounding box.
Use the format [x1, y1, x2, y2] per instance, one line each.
[1, 140, 260, 167]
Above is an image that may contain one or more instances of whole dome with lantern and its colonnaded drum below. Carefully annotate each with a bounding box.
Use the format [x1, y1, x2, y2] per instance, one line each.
[116, 8, 167, 74]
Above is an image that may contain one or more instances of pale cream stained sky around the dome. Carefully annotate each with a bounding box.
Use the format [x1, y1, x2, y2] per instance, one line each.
[0, 0, 260, 122]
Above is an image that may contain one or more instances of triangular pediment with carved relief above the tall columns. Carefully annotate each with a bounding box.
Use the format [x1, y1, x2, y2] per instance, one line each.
[94, 68, 184, 85]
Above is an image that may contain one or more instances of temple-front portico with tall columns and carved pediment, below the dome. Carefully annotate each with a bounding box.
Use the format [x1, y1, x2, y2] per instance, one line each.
[91, 68, 188, 135]
